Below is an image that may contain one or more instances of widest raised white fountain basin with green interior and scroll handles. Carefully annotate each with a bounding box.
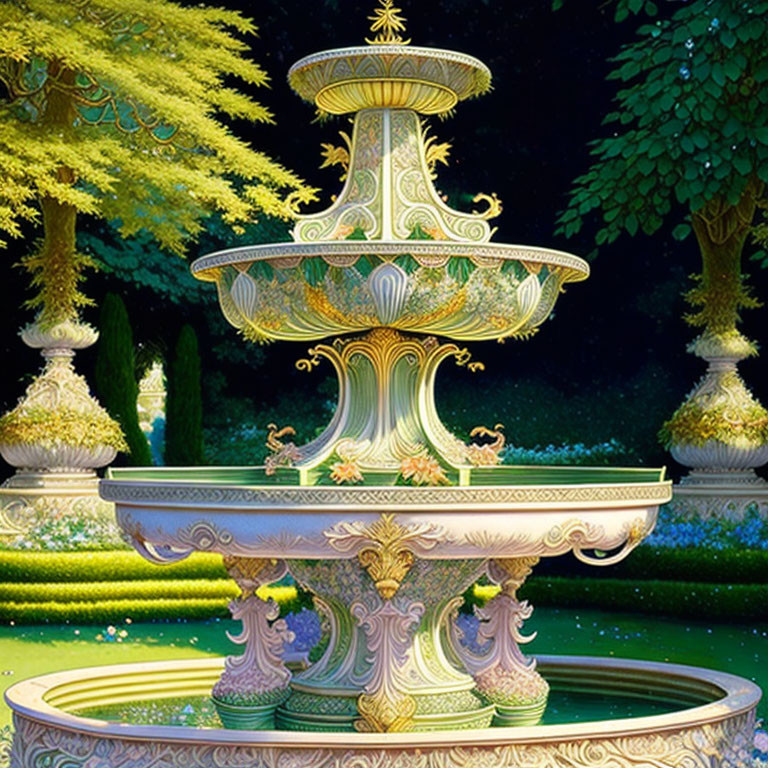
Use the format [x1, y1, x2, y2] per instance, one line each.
[100, 466, 672, 565]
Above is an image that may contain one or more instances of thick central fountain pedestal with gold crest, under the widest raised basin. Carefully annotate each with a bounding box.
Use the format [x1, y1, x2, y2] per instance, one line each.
[276, 514, 494, 732]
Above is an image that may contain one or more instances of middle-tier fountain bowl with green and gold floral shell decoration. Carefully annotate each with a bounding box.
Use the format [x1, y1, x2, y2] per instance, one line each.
[192, 240, 589, 341]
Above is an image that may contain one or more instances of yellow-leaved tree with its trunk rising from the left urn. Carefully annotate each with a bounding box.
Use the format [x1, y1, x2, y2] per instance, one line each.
[0, 0, 314, 322]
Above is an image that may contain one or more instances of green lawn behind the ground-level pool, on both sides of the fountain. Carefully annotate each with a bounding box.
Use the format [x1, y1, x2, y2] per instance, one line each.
[0, 606, 768, 727]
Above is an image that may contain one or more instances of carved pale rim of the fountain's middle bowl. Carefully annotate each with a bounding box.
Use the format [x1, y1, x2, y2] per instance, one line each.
[190, 240, 590, 282]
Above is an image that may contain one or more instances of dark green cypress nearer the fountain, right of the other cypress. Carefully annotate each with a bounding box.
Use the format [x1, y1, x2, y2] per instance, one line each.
[165, 325, 205, 466]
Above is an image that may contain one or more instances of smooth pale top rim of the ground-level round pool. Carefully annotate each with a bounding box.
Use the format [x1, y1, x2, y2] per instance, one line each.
[5, 656, 761, 750]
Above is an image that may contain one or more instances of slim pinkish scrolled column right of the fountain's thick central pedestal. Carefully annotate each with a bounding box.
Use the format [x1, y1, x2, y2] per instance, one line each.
[454, 557, 549, 725]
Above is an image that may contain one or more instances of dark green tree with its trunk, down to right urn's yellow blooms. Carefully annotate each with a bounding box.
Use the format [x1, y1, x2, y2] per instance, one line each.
[558, 0, 768, 452]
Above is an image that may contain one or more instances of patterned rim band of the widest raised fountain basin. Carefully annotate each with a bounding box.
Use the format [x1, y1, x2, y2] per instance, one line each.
[99, 480, 672, 514]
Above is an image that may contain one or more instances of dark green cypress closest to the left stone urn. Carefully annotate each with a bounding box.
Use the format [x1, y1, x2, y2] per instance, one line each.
[95, 293, 152, 467]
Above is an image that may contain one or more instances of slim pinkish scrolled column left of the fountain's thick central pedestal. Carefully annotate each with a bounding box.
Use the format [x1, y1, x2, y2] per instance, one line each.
[213, 557, 292, 730]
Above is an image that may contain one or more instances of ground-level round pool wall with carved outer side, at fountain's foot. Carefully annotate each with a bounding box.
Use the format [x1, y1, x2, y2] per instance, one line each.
[6, 656, 761, 768]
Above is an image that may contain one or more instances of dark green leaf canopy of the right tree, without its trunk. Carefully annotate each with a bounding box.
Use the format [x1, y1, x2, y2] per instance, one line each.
[559, 0, 768, 244]
